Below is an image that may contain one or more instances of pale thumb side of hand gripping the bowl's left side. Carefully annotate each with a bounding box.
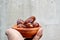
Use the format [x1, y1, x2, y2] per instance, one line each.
[6, 28, 24, 40]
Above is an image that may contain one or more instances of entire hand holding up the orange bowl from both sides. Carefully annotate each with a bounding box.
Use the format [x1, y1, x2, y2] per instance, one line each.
[6, 28, 43, 40]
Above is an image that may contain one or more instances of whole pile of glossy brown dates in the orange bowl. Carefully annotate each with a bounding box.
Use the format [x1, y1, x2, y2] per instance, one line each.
[17, 16, 40, 28]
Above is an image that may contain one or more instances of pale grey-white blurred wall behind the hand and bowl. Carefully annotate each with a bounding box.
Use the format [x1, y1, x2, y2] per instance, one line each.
[0, 0, 60, 40]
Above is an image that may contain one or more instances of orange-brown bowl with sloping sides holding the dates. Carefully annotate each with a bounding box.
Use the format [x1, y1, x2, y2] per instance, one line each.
[12, 25, 40, 38]
